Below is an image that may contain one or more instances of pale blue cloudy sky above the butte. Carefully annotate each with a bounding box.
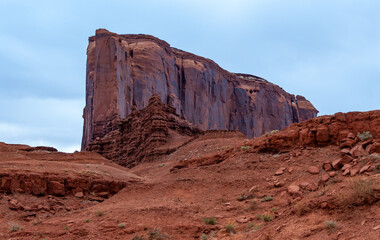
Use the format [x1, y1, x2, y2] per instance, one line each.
[0, 0, 380, 152]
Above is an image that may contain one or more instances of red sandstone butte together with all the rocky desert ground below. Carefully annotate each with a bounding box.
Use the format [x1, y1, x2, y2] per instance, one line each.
[0, 30, 380, 240]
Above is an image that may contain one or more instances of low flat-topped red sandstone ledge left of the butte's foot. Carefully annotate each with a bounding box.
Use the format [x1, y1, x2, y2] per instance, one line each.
[0, 142, 139, 199]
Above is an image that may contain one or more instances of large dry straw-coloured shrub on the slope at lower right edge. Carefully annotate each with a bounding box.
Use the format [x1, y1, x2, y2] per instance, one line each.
[337, 178, 374, 208]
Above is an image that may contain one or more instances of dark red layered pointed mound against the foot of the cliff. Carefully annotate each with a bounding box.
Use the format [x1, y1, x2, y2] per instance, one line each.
[86, 94, 202, 167]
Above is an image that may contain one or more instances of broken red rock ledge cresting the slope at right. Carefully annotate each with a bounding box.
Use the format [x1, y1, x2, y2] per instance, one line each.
[251, 110, 380, 153]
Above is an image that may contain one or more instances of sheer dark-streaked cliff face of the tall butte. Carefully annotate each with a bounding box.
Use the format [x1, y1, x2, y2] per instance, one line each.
[82, 29, 318, 149]
